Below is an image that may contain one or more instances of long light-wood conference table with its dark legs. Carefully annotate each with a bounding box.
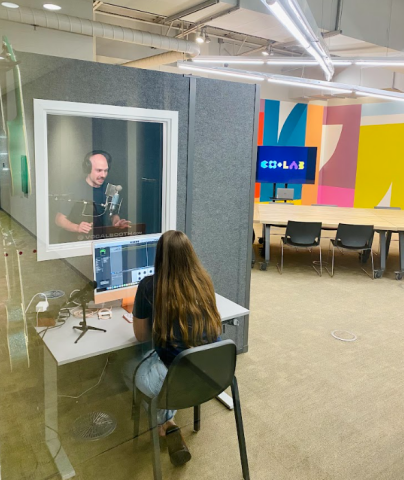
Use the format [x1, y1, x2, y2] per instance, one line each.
[254, 203, 404, 280]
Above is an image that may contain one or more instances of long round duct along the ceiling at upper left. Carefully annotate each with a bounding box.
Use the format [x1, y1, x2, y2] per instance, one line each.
[0, 7, 200, 61]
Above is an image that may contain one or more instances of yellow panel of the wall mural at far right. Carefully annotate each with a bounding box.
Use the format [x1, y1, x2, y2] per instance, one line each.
[354, 124, 404, 208]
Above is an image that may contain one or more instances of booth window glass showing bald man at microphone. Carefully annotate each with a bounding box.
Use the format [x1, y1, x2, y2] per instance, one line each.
[48, 115, 163, 244]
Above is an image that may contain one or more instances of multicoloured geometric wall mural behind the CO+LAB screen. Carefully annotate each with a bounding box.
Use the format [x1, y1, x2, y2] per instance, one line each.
[255, 100, 404, 208]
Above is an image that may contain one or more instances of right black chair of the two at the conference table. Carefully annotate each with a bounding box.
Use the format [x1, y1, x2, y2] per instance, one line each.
[325, 223, 375, 279]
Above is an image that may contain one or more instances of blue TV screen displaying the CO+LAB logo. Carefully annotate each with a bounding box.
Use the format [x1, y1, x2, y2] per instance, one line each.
[257, 146, 317, 184]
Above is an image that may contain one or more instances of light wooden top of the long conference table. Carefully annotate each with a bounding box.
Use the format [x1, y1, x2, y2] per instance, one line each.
[254, 203, 404, 231]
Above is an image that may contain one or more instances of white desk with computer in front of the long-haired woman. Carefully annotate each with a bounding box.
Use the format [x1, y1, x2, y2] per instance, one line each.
[36, 294, 250, 479]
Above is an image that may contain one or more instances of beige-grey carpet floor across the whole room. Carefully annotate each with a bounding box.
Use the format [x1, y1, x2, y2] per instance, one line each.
[0, 215, 404, 480]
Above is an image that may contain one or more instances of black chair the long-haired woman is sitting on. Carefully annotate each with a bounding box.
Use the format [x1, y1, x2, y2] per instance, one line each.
[132, 340, 250, 480]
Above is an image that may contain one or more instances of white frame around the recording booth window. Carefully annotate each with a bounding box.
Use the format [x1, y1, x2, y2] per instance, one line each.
[34, 99, 178, 261]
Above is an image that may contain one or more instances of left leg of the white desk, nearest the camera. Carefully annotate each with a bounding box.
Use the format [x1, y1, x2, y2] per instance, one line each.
[43, 345, 76, 480]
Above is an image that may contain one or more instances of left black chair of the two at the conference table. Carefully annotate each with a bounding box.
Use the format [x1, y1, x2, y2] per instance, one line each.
[276, 220, 323, 277]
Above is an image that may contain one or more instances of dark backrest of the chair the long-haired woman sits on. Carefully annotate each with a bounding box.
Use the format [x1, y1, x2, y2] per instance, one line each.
[157, 340, 237, 410]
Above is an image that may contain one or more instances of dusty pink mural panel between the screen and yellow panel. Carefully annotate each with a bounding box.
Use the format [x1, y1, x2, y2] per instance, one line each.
[319, 105, 361, 189]
